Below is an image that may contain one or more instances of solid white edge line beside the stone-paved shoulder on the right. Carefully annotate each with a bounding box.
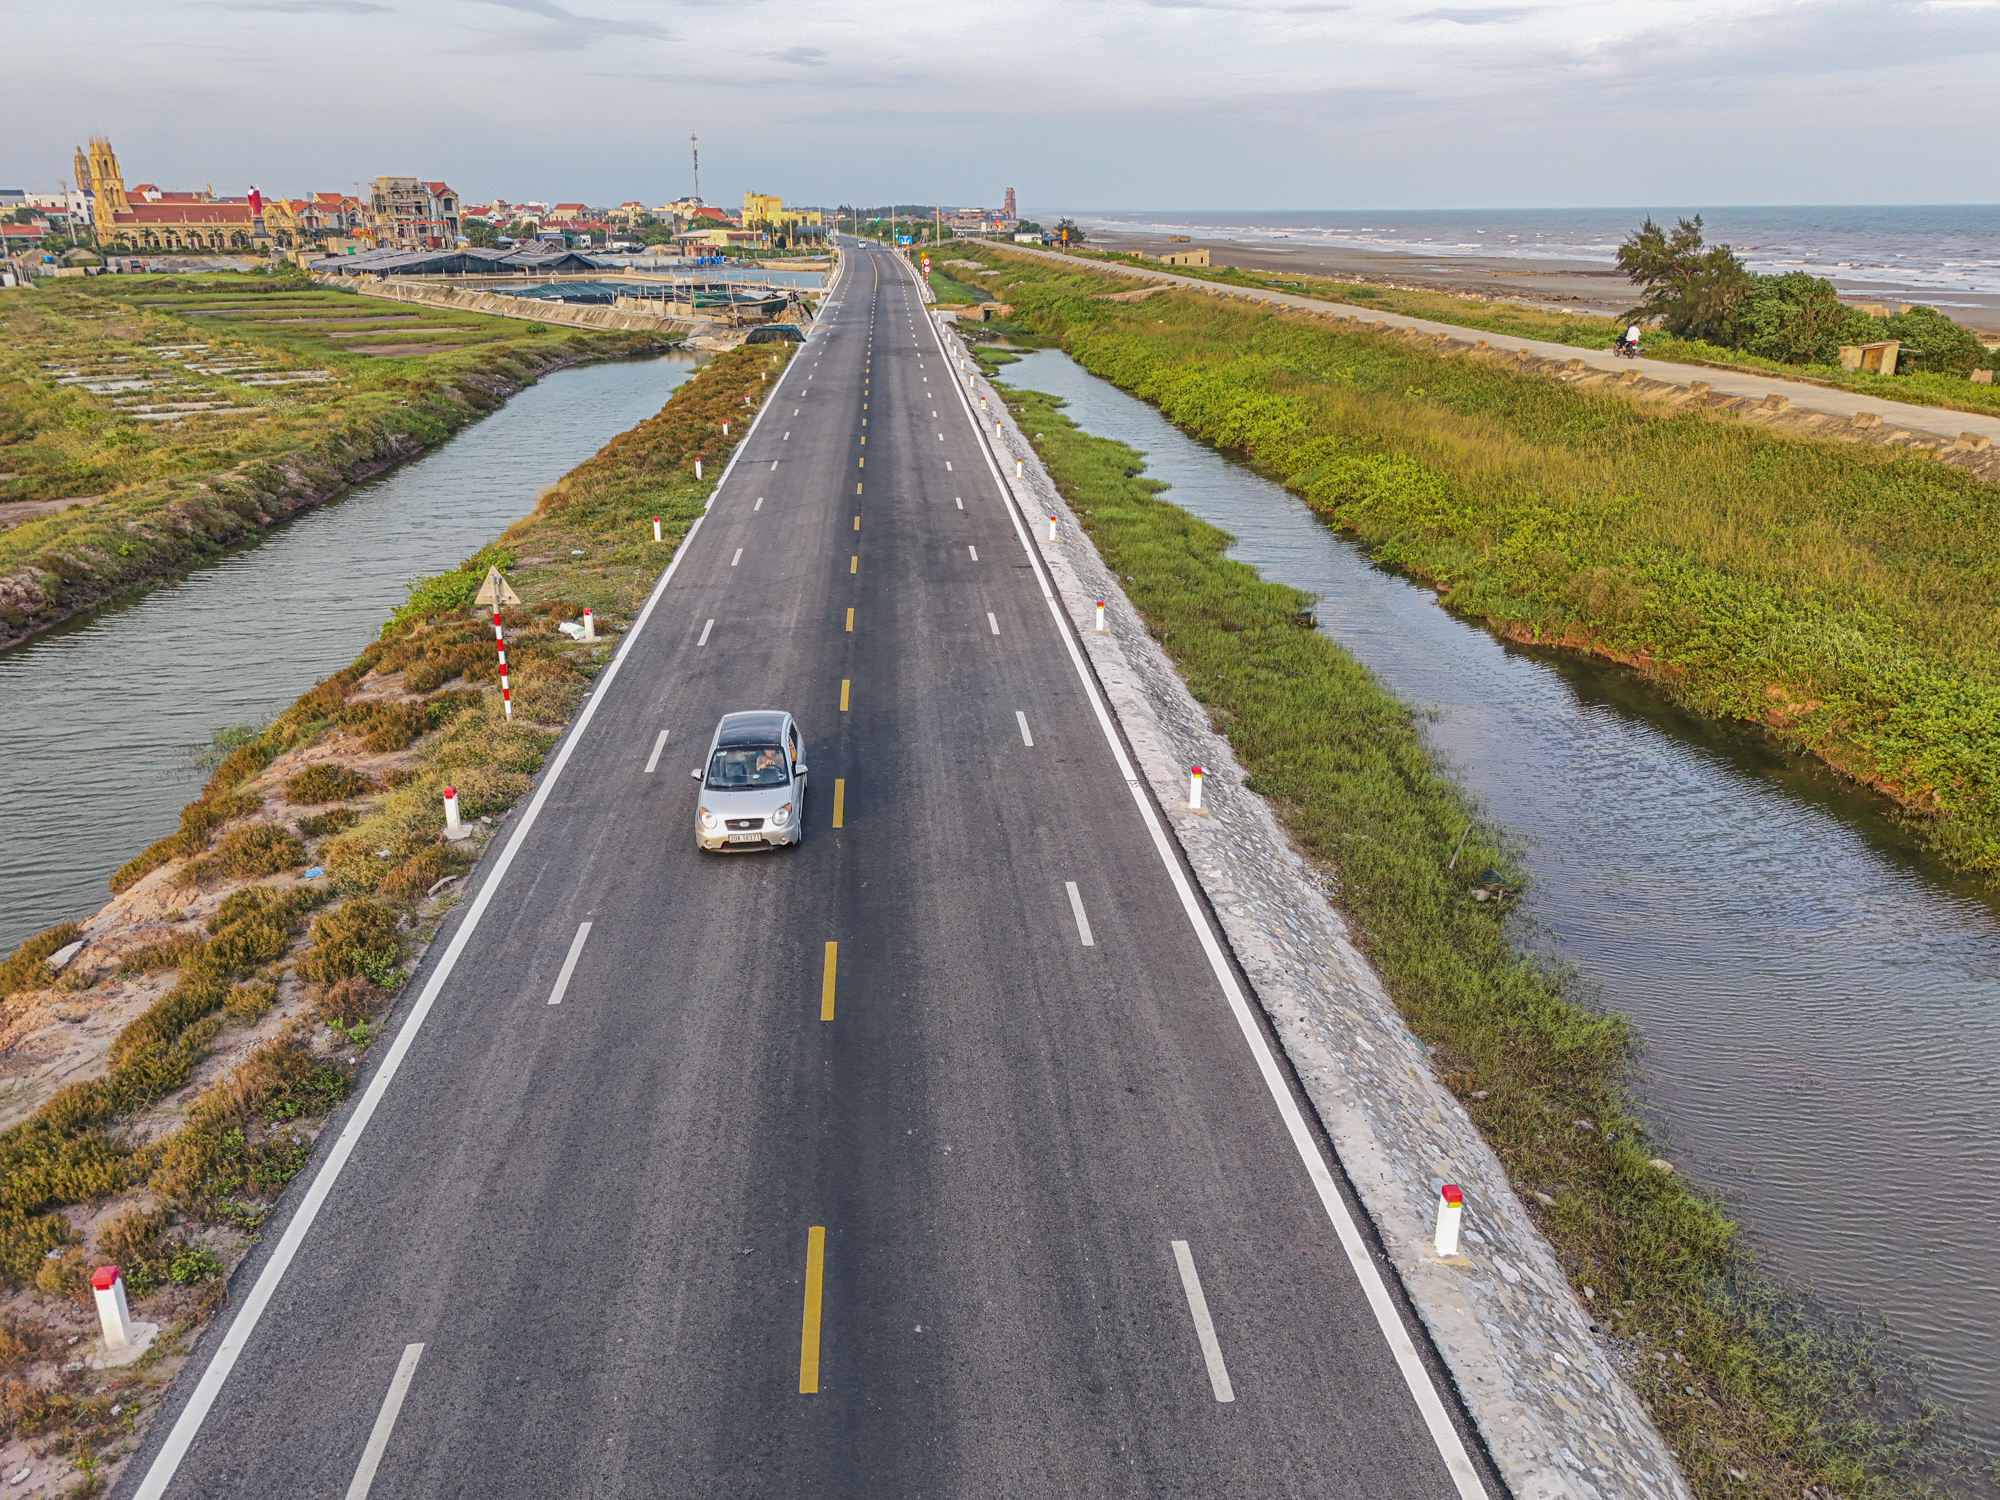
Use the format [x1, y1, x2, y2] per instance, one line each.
[908, 253, 1490, 1500]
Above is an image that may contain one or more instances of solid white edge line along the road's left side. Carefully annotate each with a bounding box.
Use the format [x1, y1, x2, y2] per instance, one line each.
[119, 258, 812, 1500]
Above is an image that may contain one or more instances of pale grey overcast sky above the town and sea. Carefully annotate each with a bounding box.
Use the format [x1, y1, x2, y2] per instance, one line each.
[0, 0, 2000, 212]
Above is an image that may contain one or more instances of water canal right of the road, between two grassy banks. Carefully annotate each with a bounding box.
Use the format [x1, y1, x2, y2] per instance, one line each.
[1002, 350, 2000, 1452]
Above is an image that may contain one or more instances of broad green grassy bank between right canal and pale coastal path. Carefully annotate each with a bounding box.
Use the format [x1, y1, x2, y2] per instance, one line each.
[948, 252, 2000, 870]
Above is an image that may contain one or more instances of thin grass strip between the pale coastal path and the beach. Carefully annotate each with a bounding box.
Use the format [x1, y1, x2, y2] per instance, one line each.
[1040, 250, 2000, 416]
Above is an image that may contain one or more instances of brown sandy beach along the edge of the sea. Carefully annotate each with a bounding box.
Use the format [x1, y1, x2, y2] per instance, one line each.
[1090, 228, 2000, 334]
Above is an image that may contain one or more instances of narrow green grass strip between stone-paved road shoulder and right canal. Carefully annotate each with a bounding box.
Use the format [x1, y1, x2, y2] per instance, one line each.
[984, 362, 1968, 1500]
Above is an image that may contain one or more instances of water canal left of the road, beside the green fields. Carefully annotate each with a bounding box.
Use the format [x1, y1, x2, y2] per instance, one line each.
[0, 354, 694, 952]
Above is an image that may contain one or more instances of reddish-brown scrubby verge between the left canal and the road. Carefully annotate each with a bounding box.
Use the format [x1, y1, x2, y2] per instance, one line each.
[0, 346, 784, 1476]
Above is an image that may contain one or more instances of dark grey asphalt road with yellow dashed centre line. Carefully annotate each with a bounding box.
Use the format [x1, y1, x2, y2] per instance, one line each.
[118, 244, 1498, 1500]
